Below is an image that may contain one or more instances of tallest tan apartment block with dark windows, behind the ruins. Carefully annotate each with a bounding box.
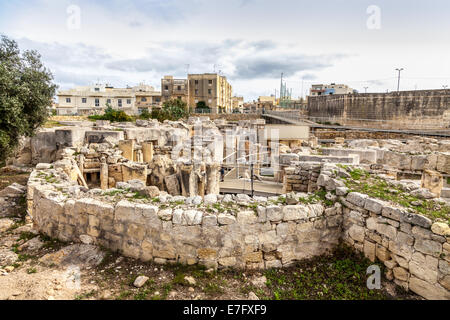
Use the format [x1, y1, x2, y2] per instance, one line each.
[161, 73, 233, 113]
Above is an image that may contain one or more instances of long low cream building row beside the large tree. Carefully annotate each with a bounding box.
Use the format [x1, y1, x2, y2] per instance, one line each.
[57, 84, 161, 115]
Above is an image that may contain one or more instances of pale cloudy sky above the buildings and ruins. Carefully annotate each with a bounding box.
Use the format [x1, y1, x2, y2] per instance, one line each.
[0, 0, 450, 100]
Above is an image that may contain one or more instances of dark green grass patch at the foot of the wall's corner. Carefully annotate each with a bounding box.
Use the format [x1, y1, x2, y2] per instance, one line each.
[264, 245, 389, 300]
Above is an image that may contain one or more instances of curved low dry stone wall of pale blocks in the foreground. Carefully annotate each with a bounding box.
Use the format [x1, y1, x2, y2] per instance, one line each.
[29, 162, 450, 299]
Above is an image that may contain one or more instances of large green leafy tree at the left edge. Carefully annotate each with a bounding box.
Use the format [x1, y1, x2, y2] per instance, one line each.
[0, 36, 57, 164]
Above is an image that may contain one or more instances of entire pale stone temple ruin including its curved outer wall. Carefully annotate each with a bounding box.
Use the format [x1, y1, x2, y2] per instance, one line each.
[7, 119, 450, 299]
